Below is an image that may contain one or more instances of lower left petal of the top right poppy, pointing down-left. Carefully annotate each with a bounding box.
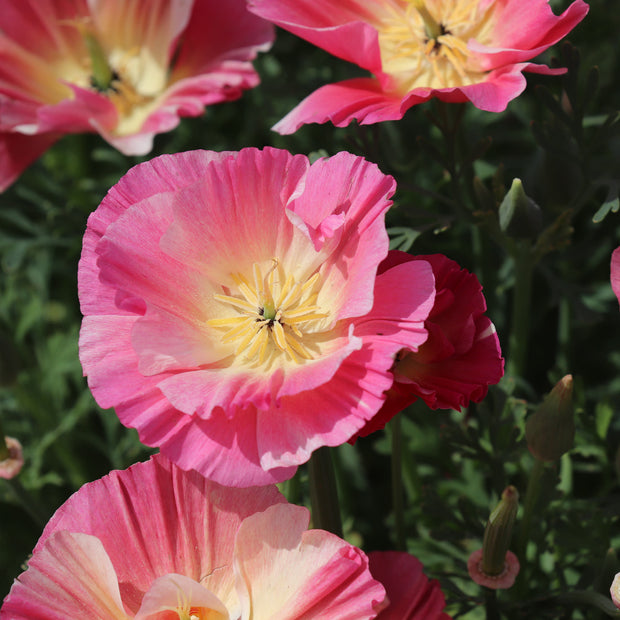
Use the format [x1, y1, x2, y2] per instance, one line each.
[273, 78, 404, 134]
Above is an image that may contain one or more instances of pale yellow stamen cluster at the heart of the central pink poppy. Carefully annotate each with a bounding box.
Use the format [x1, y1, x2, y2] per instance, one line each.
[207, 258, 327, 366]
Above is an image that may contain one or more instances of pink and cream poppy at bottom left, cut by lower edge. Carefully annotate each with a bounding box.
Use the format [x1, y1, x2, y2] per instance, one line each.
[0, 455, 385, 620]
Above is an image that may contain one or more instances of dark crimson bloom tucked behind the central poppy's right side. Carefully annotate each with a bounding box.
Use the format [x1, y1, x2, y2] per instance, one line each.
[359, 252, 504, 437]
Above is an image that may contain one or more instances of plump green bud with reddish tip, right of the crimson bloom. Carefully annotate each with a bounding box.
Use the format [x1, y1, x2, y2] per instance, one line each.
[525, 375, 575, 461]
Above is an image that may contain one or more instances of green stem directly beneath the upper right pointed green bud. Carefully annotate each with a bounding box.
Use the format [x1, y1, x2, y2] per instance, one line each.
[507, 242, 534, 377]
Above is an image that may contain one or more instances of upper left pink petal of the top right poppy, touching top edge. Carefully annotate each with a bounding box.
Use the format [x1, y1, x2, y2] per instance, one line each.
[249, 0, 385, 73]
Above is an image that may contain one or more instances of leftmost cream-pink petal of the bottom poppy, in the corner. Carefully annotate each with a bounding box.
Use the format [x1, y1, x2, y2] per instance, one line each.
[2, 531, 129, 620]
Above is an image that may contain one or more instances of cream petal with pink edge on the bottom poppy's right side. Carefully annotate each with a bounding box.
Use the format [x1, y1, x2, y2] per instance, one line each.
[235, 504, 384, 620]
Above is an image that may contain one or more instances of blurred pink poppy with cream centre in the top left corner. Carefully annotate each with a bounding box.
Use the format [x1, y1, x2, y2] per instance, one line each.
[0, 0, 273, 190]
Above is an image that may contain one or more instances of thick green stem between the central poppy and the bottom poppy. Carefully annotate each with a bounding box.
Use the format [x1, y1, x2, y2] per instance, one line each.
[308, 446, 342, 538]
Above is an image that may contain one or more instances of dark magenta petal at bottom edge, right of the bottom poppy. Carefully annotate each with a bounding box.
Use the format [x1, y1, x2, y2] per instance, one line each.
[368, 551, 450, 620]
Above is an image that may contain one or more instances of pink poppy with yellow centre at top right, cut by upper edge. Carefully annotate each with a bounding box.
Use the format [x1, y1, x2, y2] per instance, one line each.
[250, 0, 588, 134]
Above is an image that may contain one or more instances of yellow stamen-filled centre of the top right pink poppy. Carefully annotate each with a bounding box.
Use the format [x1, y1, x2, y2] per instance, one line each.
[379, 0, 495, 93]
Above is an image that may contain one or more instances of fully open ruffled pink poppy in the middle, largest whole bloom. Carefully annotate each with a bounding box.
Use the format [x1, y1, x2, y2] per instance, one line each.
[78, 149, 435, 486]
